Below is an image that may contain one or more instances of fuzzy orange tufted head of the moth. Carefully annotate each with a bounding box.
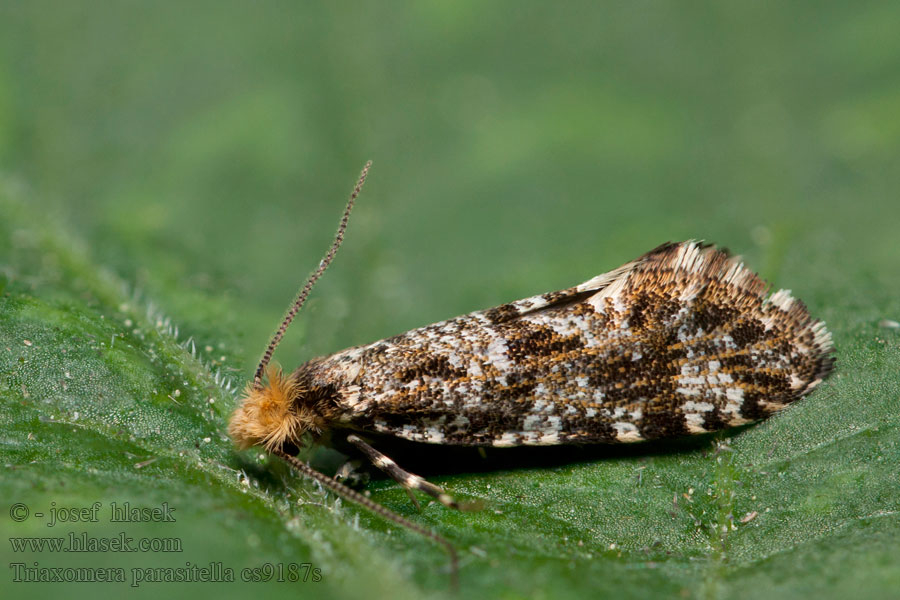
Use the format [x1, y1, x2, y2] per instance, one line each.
[228, 369, 315, 450]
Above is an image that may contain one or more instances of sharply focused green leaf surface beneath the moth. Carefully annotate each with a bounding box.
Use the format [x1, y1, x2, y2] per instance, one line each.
[0, 171, 900, 598]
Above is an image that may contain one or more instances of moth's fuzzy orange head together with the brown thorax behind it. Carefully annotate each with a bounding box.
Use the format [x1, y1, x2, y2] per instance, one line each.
[228, 349, 360, 449]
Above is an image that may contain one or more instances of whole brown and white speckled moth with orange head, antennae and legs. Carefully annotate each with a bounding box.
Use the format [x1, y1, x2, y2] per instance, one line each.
[229, 163, 834, 576]
